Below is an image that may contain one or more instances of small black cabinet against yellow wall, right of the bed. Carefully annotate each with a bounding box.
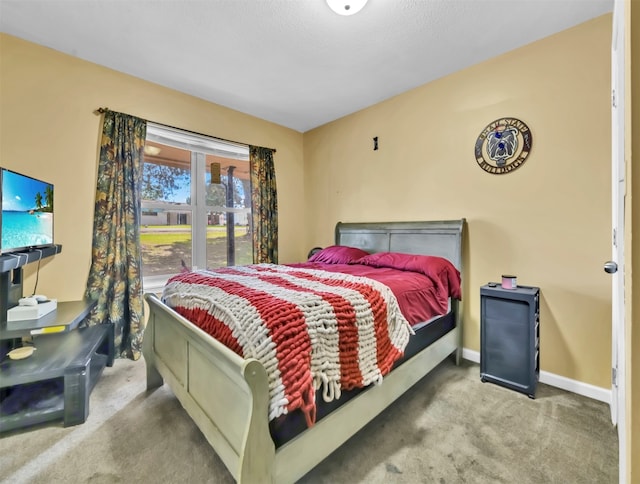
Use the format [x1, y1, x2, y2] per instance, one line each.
[480, 283, 540, 398]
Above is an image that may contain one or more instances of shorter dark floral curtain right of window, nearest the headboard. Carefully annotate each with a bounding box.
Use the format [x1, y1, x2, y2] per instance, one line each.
[249, 146, 278, 264]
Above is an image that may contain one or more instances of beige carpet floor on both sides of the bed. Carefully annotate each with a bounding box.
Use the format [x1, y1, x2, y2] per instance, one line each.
[0, 360, 618, 484]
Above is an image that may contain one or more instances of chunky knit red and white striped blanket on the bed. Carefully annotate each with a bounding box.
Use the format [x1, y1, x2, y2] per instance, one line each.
[163, 264, 413, 425]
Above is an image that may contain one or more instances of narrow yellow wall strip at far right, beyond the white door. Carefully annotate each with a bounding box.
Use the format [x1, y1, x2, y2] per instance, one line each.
[625, 1, 640, 483]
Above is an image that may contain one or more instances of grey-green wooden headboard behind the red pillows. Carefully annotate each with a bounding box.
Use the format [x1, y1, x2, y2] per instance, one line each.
[335, 219, 465, 272]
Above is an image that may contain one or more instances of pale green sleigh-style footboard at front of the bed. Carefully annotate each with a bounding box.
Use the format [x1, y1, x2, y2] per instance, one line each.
[143, 294, 275, 483]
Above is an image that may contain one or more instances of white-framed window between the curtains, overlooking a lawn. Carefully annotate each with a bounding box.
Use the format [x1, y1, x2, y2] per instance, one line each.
[140, 123, 253, 290]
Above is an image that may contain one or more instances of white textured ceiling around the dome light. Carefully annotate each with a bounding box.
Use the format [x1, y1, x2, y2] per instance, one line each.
[0, 0, 613, 132]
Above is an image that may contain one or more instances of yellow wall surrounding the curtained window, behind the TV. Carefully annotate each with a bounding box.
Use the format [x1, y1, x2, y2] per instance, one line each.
[0, 34, 304, 301]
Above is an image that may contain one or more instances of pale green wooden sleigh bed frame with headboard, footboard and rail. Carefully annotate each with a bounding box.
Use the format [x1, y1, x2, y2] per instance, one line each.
[143, 219, 465, 483]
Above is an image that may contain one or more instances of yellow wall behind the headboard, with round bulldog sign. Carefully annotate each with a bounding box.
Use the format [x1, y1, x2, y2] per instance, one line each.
[304, 15, 611, 388]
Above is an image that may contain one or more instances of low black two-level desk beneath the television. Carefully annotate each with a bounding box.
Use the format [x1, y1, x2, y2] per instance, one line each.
[0, 301, 114, 432]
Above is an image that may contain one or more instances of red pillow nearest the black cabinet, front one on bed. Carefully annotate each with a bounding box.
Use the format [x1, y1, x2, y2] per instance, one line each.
[352, 252, 461, 299]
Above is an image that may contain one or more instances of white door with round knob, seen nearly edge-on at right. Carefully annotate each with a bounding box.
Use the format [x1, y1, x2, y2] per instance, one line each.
[605, 0, 626, 482]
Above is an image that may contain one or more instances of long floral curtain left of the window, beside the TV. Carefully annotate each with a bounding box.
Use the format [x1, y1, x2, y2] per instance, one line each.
[87, 111, 147, 360]
